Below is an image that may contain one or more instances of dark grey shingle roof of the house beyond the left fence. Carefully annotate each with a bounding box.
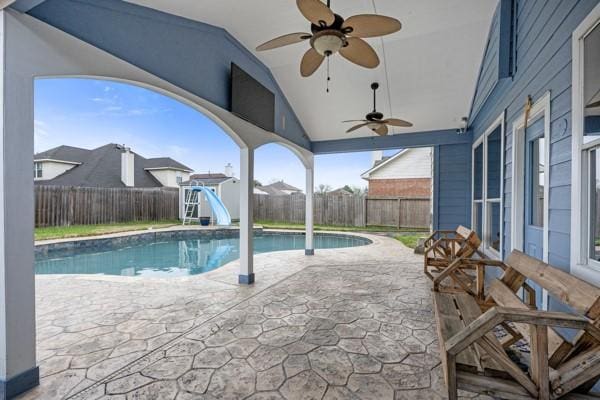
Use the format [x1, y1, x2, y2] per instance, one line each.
[34, 143, 190, 188]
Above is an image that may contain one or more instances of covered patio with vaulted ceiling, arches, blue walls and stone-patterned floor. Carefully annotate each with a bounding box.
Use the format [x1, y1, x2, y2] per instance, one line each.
[0, 0, 600, 400]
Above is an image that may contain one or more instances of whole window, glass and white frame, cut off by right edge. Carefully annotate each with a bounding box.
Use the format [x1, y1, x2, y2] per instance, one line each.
[571, 5, 600, 284]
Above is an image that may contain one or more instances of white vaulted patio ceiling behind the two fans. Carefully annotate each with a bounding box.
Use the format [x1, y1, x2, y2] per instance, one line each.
[129, 0, 498, 141]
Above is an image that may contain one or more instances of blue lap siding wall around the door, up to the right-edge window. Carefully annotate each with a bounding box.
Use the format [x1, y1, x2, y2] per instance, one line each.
[470, 0, 599, 316]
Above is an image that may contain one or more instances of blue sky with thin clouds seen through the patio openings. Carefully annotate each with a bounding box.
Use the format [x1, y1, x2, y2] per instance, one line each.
[35, 79, 371, 189]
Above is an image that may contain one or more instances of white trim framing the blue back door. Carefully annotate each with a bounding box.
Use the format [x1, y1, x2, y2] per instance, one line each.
[510, 92, 551, 310]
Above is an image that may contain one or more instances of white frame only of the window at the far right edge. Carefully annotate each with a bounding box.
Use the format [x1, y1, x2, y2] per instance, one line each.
[571, 4, 600, 285]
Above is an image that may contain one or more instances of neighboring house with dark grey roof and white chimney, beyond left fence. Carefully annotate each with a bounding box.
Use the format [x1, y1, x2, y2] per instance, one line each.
[33, 143, 192, 188]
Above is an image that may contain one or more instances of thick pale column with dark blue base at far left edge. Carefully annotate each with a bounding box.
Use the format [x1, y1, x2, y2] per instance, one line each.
[0, 11, 39, 399]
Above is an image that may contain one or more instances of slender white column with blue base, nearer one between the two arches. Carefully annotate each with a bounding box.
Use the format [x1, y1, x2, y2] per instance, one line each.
[239, 148, 254, 284]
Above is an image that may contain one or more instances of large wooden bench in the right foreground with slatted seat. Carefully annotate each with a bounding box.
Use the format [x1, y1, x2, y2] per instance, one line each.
[433, 251, 600, 399]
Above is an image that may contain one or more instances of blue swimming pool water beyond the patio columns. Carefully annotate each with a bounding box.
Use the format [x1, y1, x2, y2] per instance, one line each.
[35, 233, 370, 277]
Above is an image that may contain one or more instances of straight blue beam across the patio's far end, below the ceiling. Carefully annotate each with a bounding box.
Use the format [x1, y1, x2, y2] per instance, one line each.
[312, 129, 471, 154]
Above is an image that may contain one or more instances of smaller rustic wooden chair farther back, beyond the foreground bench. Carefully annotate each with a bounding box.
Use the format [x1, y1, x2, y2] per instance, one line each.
[424, 226, 486, 294]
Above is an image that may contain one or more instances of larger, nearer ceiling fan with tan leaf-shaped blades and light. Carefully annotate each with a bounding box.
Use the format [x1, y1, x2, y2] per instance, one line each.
[256, 0, 402, 77]
